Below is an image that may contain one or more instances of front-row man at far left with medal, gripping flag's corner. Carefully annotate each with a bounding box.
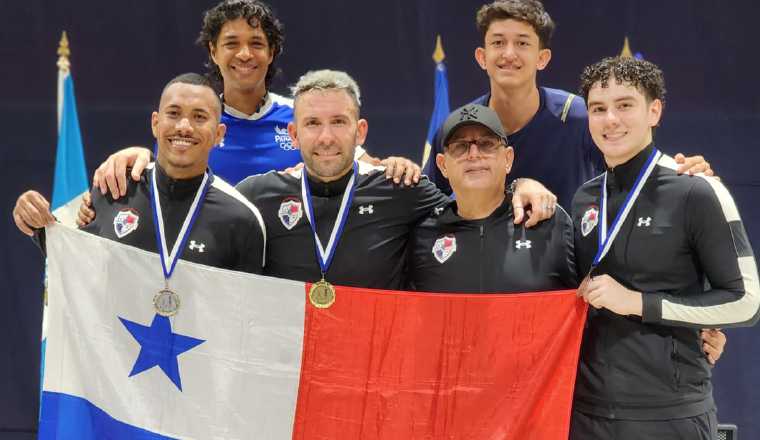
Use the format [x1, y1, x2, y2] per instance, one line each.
[13, 73, 266, 273]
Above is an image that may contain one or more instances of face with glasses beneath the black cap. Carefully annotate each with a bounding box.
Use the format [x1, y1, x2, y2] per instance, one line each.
[436, 124, 514, 194]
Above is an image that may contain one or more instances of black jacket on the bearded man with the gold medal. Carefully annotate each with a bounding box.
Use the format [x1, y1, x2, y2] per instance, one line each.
[237, 162, 448, 289]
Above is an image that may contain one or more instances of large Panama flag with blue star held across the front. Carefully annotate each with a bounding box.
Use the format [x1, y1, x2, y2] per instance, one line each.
[39, 225, 586, 440]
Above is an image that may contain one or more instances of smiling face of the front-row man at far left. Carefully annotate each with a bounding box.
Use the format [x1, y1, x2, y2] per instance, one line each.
[151, 83, 225, 179]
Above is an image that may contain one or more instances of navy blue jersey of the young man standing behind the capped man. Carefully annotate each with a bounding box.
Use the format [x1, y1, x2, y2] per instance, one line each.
[423, 87, 604, 210]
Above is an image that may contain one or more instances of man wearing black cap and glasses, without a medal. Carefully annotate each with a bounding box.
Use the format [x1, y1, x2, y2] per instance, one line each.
[408, 104, 577, 293]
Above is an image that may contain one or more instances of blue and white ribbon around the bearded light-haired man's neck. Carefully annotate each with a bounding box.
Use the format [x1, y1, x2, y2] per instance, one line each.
[301, 161, 359, 278]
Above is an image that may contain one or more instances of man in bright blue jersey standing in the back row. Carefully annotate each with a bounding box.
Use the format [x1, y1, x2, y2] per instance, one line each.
[93, 0, 420, 205]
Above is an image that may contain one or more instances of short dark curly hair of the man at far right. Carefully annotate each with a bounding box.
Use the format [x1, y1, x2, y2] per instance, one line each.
[579, 57, 665, 105]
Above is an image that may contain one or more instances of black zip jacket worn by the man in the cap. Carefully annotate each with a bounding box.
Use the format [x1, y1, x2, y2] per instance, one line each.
[408, 197, 577, 293]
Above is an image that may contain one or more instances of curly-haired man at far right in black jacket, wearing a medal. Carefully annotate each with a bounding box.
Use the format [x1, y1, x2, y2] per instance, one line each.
[570, 58, 760, 440]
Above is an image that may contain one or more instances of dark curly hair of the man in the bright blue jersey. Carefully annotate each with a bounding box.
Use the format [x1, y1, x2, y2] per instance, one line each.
[196, 0, 285, 91]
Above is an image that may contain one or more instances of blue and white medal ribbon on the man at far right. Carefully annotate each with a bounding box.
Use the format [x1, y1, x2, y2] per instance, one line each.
[591, 148, 662, 270]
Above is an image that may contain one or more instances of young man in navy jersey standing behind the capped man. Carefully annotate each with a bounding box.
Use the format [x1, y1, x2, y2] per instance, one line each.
[423, 0, 712, 207]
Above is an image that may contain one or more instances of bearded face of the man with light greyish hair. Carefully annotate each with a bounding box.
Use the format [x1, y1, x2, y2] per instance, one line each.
[288, 89, 367, 182]
